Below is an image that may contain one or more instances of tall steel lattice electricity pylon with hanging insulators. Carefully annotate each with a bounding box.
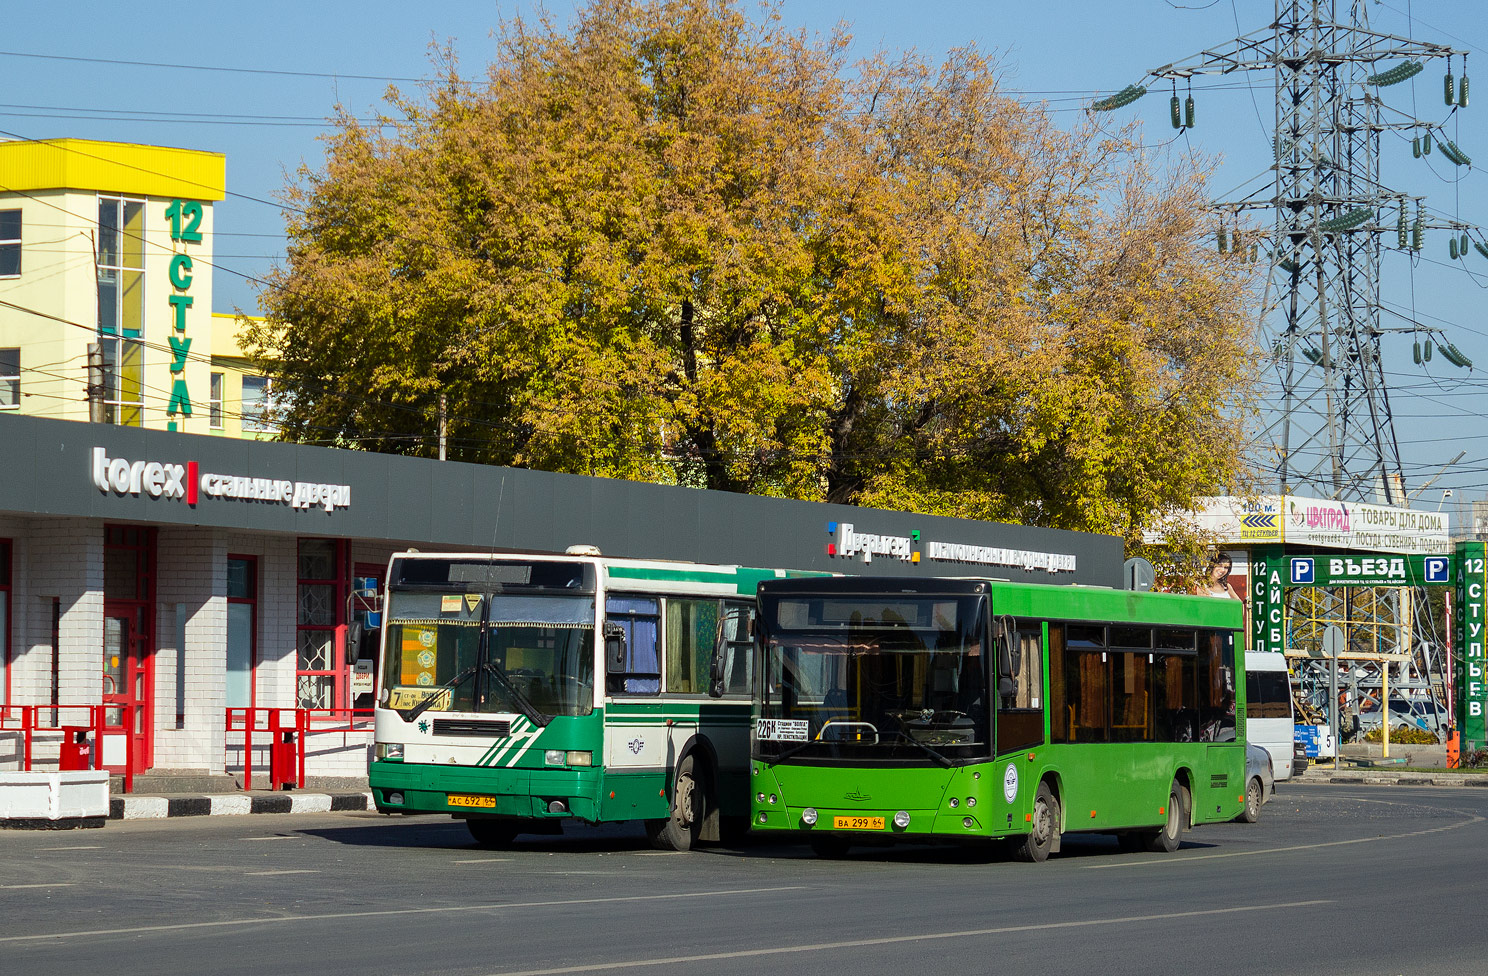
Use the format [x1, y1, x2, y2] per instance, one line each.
[1092, 0, 1472, 507]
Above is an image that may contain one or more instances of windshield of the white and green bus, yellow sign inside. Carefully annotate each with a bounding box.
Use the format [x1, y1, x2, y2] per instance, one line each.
[382, 589, 595, 717]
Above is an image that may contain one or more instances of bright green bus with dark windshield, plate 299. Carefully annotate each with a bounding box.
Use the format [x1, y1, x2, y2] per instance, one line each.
[738, 577, 1245, 861]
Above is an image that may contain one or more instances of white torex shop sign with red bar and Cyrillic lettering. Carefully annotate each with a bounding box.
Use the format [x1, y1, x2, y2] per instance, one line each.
[89, 448, 351, 512]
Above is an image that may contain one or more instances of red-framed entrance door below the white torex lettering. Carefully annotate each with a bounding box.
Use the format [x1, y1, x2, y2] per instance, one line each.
[98, 525, 158, 772]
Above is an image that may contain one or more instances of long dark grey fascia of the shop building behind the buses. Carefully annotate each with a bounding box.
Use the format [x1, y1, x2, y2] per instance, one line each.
[0, 415, 1122, 586]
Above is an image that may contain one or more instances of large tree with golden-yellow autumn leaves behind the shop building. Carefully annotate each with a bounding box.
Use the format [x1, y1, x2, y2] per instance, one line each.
[248, 0, 1253, 540]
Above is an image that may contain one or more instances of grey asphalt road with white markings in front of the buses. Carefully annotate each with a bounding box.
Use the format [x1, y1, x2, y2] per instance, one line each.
[0, 786, 1488, 976]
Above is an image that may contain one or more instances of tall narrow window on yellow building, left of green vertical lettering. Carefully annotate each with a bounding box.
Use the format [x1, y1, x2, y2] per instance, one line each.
[97, 196, 144, 427]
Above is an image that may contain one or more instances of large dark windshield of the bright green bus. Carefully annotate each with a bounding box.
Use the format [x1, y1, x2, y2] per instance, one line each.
[754, 594, 991, 765]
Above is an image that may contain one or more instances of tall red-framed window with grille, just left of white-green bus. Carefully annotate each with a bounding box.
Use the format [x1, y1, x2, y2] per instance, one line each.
[295, 539, 350, 708]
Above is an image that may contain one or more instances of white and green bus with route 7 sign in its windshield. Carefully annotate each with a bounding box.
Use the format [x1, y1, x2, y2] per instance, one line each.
[369, 546, 821, 850]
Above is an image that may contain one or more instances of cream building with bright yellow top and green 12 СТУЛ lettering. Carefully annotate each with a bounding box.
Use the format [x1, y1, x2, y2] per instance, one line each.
[0, 138, 268, 437]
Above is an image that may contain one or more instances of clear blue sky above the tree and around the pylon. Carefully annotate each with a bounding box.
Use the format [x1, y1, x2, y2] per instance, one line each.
[0, 0, 1488, 507]
